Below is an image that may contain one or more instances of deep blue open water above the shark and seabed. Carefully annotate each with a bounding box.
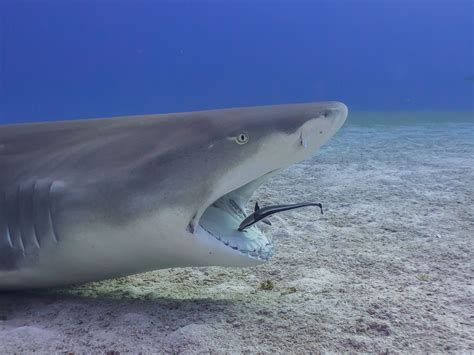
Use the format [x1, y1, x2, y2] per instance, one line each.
[0, 0, 474, 123]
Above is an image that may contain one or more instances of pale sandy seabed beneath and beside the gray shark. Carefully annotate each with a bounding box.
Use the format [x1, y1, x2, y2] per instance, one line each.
[0, 113, 474, 354]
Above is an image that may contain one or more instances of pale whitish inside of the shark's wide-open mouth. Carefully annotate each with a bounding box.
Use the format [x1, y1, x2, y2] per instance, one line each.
[194, 172, 273, 262]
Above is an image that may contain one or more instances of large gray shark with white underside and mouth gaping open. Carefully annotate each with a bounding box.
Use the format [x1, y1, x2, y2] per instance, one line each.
[0, 102, 347, 290]
